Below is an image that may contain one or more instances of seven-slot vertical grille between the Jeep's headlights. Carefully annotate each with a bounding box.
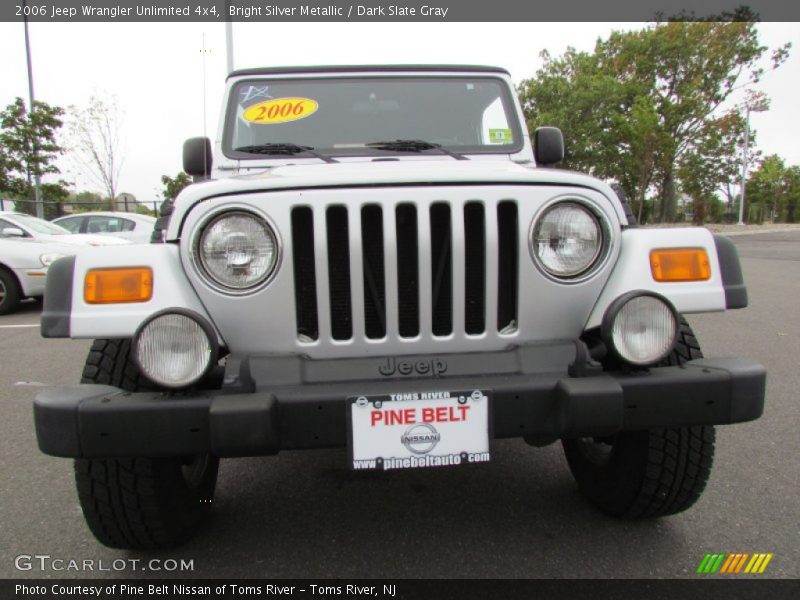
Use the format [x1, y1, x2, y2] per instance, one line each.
[292, 200, 519, 342]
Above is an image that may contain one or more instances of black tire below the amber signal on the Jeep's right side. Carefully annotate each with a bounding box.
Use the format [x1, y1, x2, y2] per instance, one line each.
[562, 317, 715, 518]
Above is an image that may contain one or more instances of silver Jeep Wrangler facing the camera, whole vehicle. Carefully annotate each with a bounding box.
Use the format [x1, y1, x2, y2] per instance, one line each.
[34, 66, 766, 548]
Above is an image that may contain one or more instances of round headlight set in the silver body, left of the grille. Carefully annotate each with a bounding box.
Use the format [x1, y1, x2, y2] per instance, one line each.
[196, 210, 278, 292]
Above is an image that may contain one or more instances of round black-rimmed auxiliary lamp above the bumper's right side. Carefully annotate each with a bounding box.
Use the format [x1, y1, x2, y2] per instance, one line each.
[603, 293, 678, 365]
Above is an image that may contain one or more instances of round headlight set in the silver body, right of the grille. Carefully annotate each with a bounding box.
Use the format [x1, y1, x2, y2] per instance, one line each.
[531, 202, 603, 279]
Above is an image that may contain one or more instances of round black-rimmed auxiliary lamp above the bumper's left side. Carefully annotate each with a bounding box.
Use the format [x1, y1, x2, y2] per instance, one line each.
[134, 313, 217, 388]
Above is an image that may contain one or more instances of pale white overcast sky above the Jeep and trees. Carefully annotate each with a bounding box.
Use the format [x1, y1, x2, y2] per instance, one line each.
[0, 23, 800, 201]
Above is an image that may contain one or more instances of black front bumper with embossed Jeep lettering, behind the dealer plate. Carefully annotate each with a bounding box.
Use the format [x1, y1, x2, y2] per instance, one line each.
[34, 342, 766, 458]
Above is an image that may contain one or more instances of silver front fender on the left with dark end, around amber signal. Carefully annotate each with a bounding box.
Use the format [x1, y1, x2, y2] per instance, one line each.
[41, 244, 219, 338]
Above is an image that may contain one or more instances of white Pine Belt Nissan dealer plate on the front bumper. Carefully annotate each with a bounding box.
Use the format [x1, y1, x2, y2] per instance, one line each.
[347, 390, 491, 471]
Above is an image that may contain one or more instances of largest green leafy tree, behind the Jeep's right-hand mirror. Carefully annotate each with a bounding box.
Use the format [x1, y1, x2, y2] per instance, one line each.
[519, 21, 789, 220]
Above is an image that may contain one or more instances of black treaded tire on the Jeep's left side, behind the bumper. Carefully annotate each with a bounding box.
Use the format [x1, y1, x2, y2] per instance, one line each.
[75, 339, 219, 550]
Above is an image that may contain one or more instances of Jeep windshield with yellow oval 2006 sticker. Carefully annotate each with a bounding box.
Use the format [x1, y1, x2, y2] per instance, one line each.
[224, 76, 522, 159]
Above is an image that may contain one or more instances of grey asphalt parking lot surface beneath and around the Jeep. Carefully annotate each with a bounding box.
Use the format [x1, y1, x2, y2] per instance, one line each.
[0, 231, 800, 578]
